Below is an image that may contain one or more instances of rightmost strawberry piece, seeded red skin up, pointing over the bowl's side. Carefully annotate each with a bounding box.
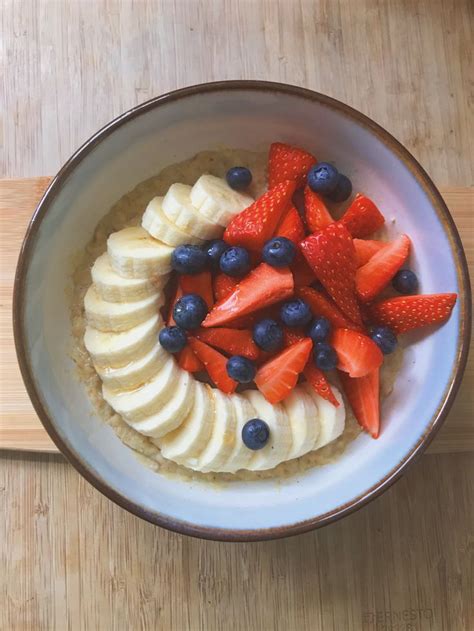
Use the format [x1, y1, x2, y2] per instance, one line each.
[370, 294, 457, 334]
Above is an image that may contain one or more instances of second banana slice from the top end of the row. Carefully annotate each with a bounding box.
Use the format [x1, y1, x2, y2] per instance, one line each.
[162, 184, 222, 241]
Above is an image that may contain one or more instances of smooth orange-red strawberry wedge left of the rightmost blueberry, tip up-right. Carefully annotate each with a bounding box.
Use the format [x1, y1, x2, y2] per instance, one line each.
[356, 234, 410, 302]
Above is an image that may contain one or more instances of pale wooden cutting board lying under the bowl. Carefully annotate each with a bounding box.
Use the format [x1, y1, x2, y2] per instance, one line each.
[0, 177, 474, 453]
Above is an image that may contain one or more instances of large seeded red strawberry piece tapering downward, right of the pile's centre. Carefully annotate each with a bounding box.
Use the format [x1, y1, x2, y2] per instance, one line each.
[300, 223, 362, 324]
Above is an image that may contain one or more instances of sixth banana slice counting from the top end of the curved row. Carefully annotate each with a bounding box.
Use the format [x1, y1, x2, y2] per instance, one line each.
[84, 285, 165, 332]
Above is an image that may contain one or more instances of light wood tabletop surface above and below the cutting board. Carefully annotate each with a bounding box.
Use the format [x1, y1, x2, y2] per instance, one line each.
[0, 0, 474, 631]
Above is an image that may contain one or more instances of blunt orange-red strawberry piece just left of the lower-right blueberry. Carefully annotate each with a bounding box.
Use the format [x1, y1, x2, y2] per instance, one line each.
[331, 329, 383, 377]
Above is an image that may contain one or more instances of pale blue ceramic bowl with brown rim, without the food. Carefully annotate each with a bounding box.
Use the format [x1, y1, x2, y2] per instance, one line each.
[13, 81, 471, 541]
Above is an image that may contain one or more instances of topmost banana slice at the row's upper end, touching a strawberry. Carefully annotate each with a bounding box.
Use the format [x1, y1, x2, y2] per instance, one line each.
[191, 175, 254, 227]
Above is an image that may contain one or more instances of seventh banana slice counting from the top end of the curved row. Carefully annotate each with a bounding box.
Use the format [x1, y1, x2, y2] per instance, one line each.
[84, 313, 163, 369]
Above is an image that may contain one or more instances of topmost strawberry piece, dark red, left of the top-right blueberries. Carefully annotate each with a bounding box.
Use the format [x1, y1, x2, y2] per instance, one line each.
[268, 142, 317, 188]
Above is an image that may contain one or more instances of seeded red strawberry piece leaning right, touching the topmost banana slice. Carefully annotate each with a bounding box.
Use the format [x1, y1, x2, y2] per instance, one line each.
[224, 180, 296, 250]
